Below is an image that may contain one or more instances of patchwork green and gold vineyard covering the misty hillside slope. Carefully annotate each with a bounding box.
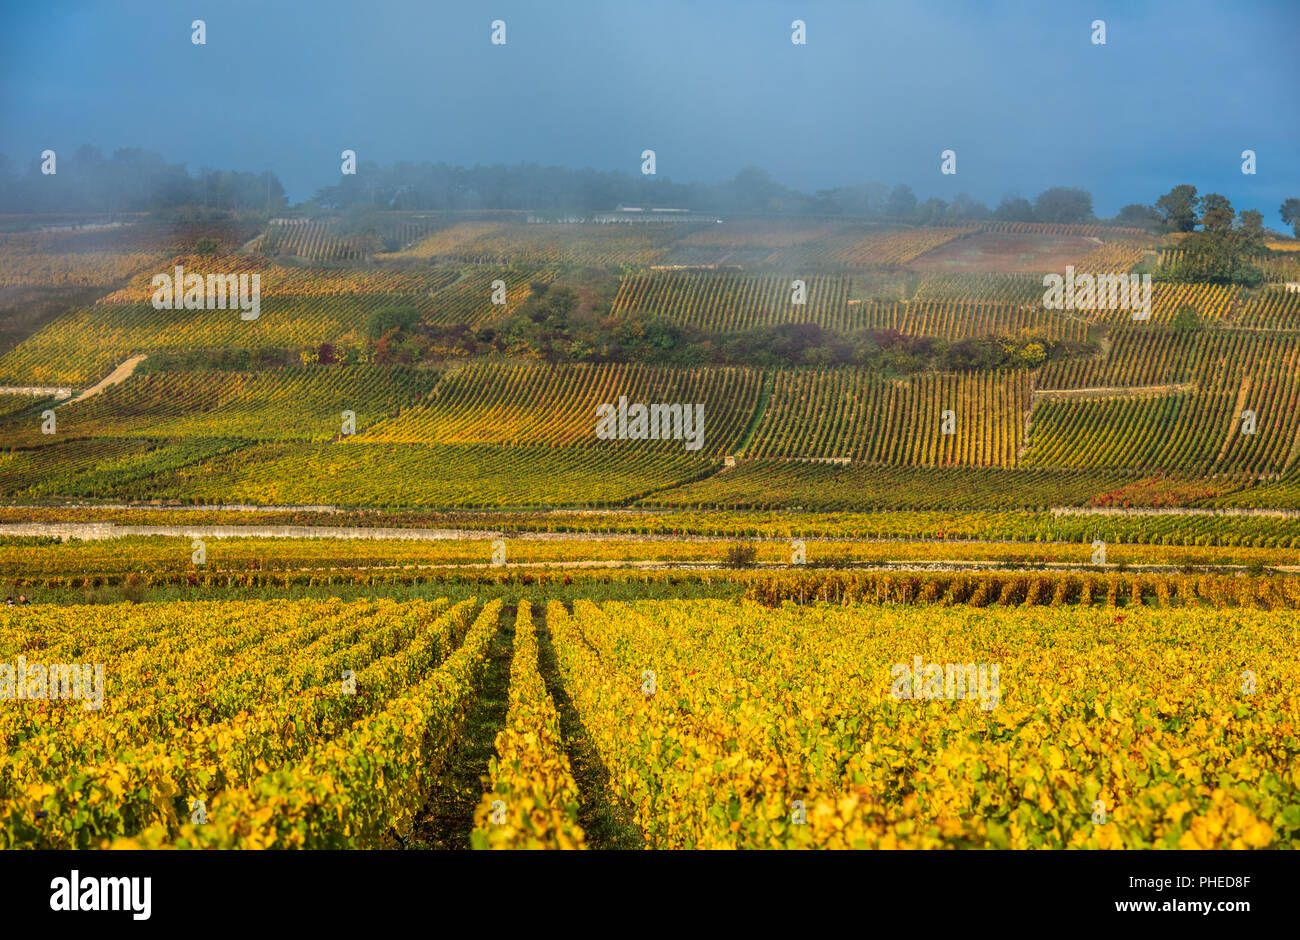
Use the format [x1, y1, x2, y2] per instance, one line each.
[0, 212, 1300, 511]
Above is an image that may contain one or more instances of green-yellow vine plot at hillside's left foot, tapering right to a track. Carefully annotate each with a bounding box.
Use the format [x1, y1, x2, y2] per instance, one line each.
[15, 437, 720, 508]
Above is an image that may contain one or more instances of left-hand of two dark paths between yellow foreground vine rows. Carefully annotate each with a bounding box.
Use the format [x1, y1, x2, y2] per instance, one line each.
[408, 605, 516, 849]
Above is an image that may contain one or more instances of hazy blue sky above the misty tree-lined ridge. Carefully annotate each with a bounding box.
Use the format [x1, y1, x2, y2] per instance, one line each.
[0, 0, 1300, 221]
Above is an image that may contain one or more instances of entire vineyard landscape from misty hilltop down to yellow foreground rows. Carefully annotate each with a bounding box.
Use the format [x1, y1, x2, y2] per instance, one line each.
[0, 211, 1300, 850]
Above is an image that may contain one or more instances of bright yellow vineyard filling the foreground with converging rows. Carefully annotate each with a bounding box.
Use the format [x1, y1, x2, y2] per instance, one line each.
[0, 595, 1300, 849]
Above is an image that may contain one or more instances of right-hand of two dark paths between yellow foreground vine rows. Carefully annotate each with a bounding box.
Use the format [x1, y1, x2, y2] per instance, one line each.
[533, 605, 645, 849]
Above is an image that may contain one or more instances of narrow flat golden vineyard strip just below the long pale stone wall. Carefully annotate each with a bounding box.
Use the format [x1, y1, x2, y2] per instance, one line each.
[0, 535, 1300, 587]
